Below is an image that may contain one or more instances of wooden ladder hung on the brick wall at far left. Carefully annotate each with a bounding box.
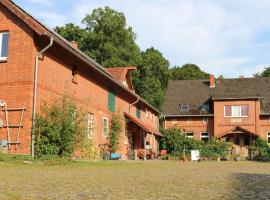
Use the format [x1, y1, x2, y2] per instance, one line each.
[0, 102, 26, 149]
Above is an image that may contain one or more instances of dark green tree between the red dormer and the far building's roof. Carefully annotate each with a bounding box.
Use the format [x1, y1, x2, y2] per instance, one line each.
[133, 47, 170, 109]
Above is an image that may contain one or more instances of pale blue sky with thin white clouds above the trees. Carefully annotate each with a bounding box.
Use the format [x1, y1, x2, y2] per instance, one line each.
[14, 0, 270, 77]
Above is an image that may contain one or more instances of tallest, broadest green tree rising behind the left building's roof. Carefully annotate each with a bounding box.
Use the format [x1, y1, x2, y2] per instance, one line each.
[55, 7, 140, 67]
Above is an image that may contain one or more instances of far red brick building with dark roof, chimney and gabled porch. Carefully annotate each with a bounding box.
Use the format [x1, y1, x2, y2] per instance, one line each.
[162, 75, 270, 155]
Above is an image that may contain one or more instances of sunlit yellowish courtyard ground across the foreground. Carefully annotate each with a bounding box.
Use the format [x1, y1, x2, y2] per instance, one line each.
[0, 161, 270, 200]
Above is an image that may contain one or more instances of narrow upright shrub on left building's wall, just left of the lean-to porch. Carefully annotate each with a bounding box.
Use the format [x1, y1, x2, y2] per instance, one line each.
[109, 113, 122, 153]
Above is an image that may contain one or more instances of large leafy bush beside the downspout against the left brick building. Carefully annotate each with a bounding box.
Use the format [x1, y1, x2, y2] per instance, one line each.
[35, 96, 87, 157]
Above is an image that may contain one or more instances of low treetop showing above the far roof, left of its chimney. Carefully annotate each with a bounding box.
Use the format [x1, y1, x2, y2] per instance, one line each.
[170, 64, 210, 80]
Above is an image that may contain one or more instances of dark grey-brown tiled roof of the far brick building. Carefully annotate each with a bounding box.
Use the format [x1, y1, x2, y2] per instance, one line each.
[162, 77, 270, 116]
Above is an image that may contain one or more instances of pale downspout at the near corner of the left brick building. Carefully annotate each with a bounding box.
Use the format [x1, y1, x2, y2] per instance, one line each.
[31, 33, 53, 158]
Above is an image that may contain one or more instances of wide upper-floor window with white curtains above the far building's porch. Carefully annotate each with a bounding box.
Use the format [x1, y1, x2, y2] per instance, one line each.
[224, 105, 248, 117]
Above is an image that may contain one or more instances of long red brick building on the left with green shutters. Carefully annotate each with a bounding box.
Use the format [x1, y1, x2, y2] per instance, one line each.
[0, 0, 160, 158]
